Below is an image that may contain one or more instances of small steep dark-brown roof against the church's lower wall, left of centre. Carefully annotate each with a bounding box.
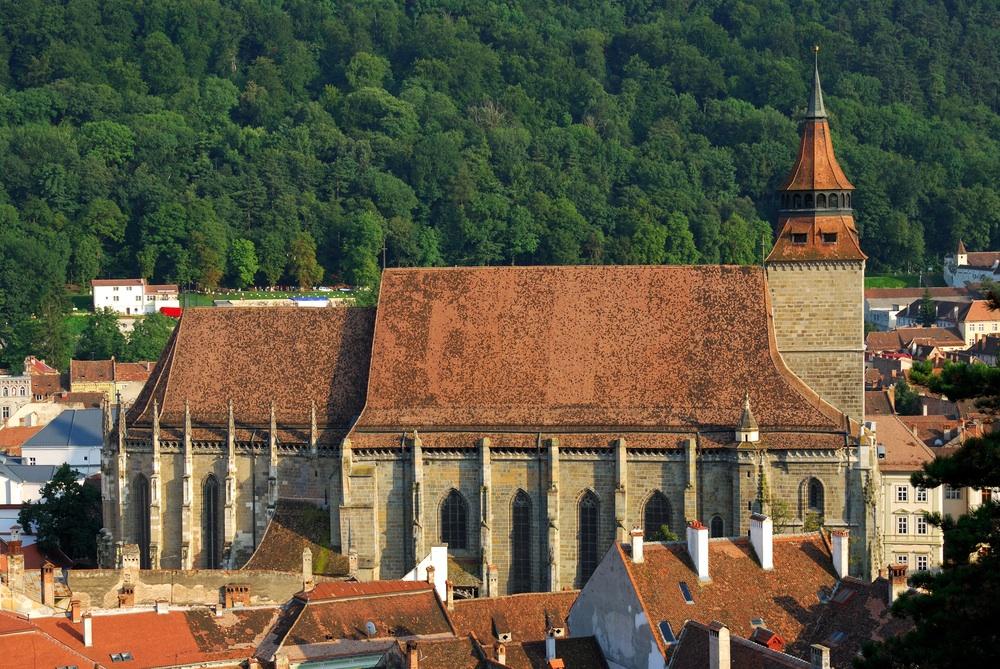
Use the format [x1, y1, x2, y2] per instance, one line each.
[243, 499, 348, 576]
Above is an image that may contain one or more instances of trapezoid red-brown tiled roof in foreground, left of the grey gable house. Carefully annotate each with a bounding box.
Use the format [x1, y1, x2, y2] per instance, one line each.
[284, 581, 454, 646]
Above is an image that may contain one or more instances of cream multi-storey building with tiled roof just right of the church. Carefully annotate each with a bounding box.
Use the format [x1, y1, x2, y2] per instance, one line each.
[873, 416, 944, 572]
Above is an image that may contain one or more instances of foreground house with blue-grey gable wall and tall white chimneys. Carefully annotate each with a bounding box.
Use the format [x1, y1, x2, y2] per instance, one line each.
[569, 514, 904, 669]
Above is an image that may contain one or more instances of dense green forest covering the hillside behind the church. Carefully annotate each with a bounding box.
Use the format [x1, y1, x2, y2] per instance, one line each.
[0, 0, 1000, 366]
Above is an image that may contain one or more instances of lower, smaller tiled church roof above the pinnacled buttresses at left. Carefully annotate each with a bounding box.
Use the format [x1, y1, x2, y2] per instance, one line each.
[128, 307, 374, 438]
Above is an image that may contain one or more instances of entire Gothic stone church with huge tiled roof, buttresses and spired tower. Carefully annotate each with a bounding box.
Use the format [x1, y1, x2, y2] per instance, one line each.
[102, 62, 878, 596]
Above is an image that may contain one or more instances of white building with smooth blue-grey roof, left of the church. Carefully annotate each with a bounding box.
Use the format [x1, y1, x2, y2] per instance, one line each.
[21, 409, 104, 476]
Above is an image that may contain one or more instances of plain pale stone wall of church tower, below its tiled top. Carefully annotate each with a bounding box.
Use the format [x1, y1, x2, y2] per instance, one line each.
[767, 261, 865, 422]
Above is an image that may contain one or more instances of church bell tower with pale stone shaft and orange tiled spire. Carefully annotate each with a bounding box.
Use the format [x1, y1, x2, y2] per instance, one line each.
[764, 47, 867, 422]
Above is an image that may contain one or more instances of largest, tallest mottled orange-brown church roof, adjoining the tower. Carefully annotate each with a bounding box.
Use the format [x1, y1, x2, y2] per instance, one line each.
[356, 266, 843, 431]
